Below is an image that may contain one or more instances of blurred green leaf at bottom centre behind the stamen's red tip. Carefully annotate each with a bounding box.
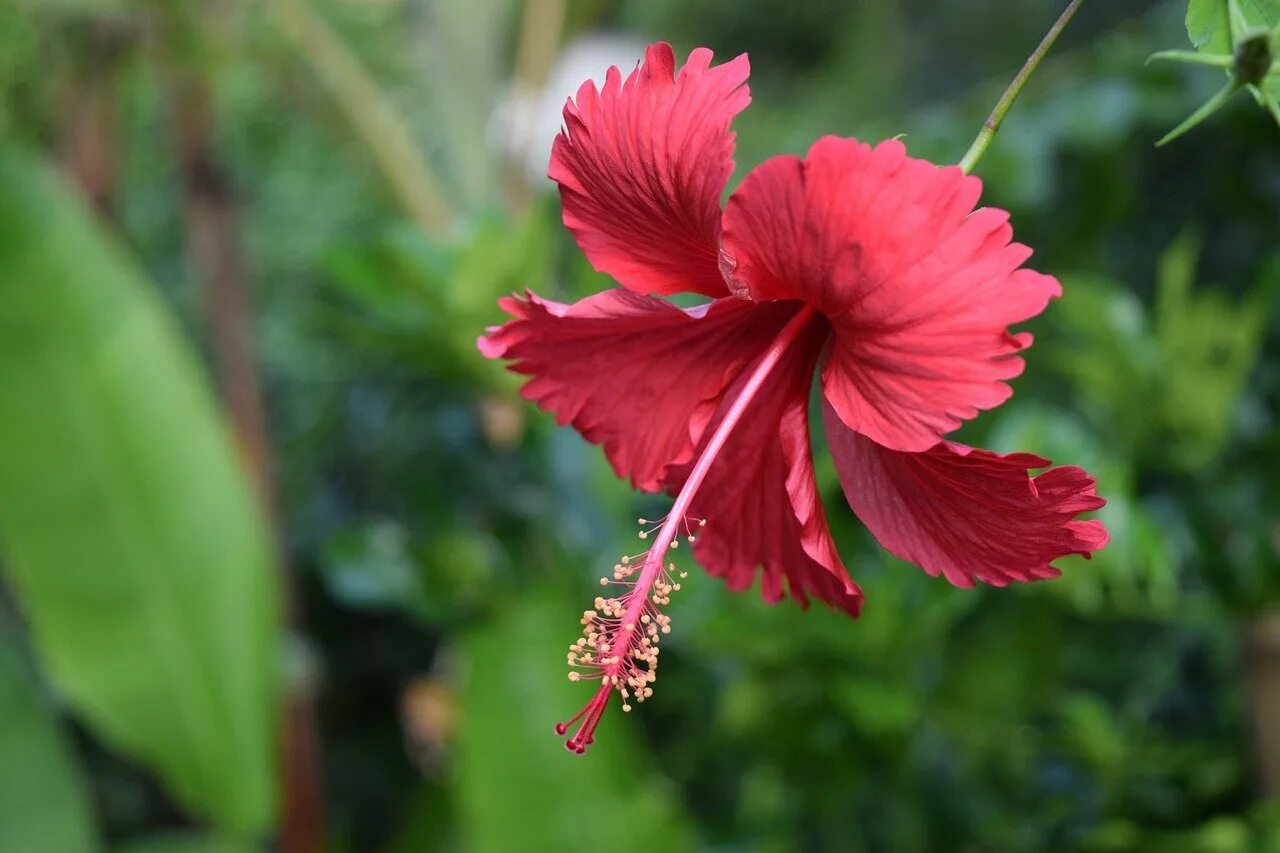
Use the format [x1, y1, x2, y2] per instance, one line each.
[456, 584, 694, 853]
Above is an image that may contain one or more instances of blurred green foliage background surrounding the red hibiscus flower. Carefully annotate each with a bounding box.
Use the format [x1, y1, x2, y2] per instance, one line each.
[0, 0, 1280, 853]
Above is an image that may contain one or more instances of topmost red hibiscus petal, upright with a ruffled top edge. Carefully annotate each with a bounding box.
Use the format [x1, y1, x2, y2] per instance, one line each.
[549, 44, 751, 297]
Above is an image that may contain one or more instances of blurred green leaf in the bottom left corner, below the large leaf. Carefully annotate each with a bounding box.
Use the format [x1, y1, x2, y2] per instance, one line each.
[0, 627, 99, 853]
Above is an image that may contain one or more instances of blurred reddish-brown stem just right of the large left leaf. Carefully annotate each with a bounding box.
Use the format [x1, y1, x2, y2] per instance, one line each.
[173, 70, 324, 853]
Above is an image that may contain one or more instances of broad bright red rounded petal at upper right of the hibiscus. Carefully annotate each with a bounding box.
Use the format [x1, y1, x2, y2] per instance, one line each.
[722, 137, 1061, 451]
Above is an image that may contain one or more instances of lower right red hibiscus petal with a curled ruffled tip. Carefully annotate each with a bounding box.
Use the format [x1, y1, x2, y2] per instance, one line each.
[823, 405, 1107, 587]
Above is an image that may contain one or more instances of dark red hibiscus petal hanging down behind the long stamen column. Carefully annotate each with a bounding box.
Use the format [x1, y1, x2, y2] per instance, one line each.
[667, 315, 863, 616]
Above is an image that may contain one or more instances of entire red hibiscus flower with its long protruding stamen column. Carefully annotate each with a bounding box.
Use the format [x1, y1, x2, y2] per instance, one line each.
[479, 44, 1107, 752]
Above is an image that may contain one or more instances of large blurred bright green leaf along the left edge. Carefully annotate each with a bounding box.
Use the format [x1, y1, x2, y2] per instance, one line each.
[0, 149, 276, 833]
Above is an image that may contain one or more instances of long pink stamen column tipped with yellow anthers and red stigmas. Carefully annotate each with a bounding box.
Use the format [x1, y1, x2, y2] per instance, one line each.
[556, 306, 817, 754]
